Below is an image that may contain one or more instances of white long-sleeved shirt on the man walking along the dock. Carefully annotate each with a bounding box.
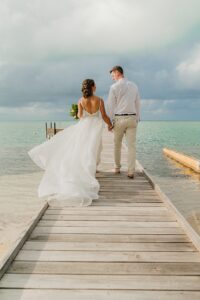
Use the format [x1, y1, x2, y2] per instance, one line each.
[106, 78, 140, 121]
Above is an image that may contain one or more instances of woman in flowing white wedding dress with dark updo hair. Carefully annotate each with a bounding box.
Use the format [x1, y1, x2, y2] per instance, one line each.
[28, 79, 112, 207]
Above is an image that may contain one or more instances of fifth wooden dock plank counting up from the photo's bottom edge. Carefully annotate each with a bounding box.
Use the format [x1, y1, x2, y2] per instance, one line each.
[22, 241, 196, 252]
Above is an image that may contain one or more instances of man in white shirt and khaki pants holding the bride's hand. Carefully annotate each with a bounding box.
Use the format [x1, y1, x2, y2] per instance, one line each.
[107, 66, 140, 179]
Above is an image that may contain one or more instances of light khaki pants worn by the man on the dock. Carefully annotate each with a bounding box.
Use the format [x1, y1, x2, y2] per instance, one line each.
[113, 115, 137, 174]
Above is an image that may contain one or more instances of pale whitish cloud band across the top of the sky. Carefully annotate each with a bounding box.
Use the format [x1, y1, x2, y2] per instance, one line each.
[0, 0, 200, 62]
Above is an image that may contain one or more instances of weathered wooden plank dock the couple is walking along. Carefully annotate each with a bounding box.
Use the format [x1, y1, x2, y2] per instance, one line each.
[0, 131, 200, 300]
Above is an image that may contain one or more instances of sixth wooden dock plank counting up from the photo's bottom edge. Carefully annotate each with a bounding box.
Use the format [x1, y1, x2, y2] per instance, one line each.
[29, 232, 189, 243]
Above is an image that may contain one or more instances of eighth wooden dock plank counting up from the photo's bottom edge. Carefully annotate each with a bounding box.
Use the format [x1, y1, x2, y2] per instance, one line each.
[38, 220, 179, 228]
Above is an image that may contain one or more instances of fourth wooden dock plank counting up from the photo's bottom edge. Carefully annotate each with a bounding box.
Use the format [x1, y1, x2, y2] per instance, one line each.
[15, 250, 200, 262]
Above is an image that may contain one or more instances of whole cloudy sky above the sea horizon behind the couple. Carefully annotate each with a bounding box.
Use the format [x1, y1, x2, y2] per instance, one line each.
[0, 0, 200, 121]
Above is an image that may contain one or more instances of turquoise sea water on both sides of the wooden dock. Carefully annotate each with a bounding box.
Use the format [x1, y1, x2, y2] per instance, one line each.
[0, 119, 200, 234]
